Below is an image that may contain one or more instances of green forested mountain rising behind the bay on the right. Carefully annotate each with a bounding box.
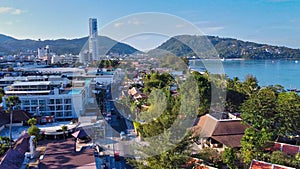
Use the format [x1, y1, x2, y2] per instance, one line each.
[149, 35, 300, 59]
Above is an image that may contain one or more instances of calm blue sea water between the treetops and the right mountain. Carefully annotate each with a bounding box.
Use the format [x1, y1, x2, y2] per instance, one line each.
[190, 60, 300, 89]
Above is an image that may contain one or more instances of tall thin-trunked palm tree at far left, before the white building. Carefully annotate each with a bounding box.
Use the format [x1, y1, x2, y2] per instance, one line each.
[6, 96, 21, 148]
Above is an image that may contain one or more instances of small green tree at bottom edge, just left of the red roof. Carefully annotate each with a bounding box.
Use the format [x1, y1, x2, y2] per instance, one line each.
[222, 148, 238, 169]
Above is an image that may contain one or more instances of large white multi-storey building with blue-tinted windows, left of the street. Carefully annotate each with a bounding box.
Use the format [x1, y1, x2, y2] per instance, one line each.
[2, 81, 89, 120]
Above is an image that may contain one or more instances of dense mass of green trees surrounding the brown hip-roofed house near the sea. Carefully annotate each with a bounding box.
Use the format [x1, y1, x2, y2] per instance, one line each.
[125, 68, 300, 169]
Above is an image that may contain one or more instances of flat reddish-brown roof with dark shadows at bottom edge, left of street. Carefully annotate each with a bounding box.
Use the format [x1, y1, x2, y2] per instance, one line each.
[39, 139, 95, 169]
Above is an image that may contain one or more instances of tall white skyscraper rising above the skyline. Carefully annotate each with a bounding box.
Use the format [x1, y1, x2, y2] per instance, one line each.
[88, 18, 99, 62]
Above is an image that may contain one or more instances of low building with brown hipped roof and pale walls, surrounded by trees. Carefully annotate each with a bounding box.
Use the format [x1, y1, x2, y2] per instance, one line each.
[193, 112, 249, 151]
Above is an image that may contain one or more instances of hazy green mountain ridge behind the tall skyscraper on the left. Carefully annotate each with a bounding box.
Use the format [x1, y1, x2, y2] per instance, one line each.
[0, 34, 139, 55]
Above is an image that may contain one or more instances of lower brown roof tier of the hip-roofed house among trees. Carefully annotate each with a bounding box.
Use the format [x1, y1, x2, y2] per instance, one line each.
[211, 134, 243, 148]
